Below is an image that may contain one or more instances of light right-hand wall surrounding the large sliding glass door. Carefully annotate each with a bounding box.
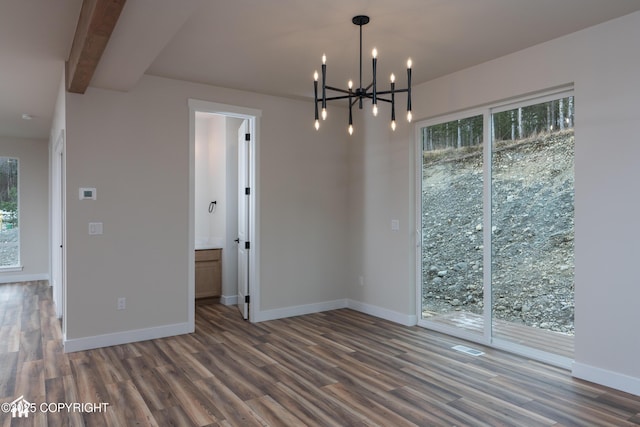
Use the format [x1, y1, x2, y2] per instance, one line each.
[349, 13, 640, 394]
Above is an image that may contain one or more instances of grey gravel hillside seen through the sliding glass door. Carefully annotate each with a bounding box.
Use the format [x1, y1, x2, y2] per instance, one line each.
[423, 131, 574, 334]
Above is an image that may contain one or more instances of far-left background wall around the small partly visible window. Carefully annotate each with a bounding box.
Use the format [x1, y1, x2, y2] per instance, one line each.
[0, 137, 49, 283]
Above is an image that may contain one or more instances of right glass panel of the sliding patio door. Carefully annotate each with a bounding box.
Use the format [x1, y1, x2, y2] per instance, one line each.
[491, 96, 574, 357]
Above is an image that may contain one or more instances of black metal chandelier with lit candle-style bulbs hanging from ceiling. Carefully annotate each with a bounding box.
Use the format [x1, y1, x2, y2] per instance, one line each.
[313, 15, 412, 135]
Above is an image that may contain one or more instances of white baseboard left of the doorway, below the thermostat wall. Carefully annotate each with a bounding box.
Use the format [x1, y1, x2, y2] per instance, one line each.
[63, 323, 194, 353]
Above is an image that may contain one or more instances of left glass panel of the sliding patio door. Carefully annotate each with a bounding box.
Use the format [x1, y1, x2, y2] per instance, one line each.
[420, 115, 484, 335]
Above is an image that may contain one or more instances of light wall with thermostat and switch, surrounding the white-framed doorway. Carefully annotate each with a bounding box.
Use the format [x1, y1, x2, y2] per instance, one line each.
[66, 76, 347, 348]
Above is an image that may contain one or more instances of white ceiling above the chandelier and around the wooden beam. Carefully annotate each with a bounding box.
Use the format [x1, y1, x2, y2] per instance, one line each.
[0, 0, 640, 138]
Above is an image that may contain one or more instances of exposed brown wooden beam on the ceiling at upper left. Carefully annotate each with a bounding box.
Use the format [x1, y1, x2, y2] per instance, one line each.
[66, 0, 126, 93]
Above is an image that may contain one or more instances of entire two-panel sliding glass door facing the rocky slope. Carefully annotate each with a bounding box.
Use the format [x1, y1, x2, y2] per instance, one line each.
[418, 92, 574, 362]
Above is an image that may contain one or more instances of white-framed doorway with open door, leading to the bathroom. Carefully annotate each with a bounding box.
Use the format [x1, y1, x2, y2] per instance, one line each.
[188, 99, 261, 325]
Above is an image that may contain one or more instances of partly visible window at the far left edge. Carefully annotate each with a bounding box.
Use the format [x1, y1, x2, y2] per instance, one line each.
[0, 157, 20, 268]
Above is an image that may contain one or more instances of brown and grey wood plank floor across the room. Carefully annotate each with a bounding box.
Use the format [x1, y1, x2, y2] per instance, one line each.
[0, 282, 640, 427]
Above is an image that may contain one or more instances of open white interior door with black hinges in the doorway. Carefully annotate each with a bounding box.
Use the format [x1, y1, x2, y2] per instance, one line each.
[236, 120, 251, 319]
